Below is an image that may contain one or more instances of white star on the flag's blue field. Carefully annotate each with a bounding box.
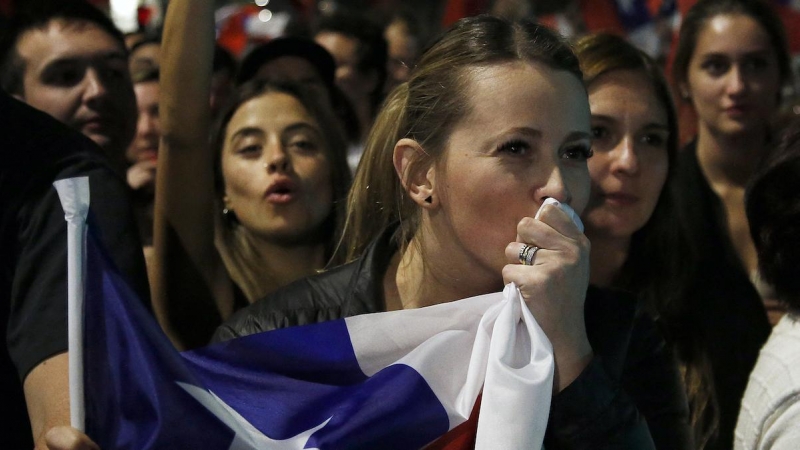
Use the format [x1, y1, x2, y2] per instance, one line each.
[178, 382, 333, 450]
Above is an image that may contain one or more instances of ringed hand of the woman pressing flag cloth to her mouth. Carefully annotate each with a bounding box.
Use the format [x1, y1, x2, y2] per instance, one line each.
[503, 205, 592, 392]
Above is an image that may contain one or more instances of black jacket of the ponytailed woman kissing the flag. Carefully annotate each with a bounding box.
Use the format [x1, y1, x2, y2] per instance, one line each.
[215, 230, 691, 450]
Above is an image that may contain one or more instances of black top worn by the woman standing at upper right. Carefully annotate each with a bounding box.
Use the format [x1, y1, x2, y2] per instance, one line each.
[669, 143, 771, 450]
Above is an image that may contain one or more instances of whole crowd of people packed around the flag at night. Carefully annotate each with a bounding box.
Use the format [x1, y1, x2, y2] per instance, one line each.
[0, 0, 800, 449]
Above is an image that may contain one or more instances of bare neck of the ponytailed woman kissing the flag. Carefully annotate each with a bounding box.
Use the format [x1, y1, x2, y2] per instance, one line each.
[384, 229, 503, 309]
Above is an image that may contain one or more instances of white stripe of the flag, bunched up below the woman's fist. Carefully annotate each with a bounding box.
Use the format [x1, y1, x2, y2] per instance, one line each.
[345, 283, 555, 450]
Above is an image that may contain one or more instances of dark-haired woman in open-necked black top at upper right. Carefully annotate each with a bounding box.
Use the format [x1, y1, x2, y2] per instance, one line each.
[673, 0, 790, 448]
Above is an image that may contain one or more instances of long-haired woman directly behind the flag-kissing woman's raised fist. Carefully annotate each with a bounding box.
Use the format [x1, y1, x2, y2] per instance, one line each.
[575, 34, 713, 448]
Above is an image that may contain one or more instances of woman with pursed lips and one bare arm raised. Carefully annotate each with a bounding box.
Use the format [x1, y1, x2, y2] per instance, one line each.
[152, 0, 350, 348]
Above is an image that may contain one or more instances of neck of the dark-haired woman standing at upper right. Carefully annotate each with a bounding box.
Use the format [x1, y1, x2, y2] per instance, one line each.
[697, 125, 767, 187]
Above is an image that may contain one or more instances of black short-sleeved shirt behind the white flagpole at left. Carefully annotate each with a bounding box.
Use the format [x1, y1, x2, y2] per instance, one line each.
[0, 91, 150, 448]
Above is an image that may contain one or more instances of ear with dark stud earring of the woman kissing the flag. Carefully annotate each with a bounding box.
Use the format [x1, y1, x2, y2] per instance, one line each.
[393, 138, 439, 208]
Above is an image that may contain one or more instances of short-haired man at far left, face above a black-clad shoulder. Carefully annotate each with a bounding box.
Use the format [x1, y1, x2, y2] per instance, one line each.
[0, 0, 136, 170]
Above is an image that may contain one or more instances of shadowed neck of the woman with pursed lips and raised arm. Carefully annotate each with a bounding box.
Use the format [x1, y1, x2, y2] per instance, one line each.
[252, 238, 327, 287]
